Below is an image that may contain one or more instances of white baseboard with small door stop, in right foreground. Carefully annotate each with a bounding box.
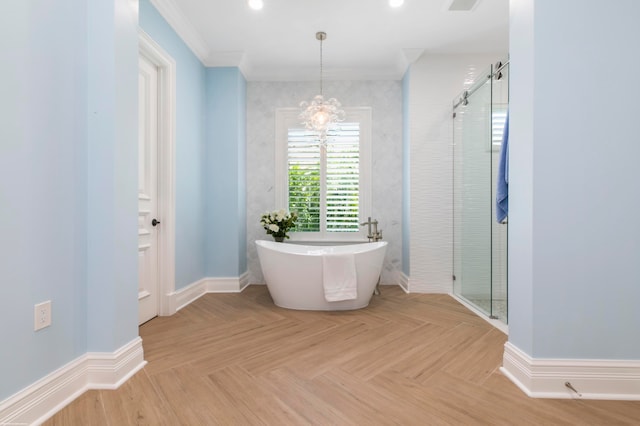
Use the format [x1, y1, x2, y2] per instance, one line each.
[500, 342, 640, 401]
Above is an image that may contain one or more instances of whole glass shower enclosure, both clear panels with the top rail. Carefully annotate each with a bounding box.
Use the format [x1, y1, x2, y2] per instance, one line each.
[453, 63, 509, 325]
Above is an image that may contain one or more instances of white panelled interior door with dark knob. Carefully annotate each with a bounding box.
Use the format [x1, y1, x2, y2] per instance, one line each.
[138, 56, 162, 324]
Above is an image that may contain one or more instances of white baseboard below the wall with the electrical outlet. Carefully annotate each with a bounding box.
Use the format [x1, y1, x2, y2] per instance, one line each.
[0, 337, 146, 425]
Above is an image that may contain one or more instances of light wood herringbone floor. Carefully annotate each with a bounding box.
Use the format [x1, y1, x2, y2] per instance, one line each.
[46, 286, 640, 426]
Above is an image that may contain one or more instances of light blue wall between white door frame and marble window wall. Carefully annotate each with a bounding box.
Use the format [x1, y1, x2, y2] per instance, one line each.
[140, 0, 247, 282]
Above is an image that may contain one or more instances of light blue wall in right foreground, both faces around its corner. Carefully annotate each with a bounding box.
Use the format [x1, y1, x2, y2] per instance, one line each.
[509, 0, 640, 360]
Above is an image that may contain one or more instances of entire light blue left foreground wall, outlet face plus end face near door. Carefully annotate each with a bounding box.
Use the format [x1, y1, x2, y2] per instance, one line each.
[0, 0, 137, 400]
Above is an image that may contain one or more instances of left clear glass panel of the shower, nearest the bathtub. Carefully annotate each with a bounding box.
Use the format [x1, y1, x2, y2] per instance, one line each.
[453, 68, 494, 317]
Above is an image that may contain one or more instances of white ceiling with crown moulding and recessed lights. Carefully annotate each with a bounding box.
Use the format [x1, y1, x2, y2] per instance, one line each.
[151, 0, 509, 81]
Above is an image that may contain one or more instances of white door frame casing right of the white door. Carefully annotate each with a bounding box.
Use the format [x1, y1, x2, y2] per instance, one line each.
[138, 29, 176, 316]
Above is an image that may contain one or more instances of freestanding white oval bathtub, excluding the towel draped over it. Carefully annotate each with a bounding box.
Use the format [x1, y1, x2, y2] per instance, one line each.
[256, 240, 387, 311]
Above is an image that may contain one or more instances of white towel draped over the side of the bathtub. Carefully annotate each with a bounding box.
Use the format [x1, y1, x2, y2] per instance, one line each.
[322, 253, 358, 302]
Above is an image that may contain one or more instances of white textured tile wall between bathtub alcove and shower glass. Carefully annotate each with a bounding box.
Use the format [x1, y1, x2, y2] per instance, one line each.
[407, 54, 501, 293]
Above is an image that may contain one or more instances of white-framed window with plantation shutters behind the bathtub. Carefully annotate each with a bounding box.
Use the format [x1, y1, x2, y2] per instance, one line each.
[276, 108, 371, 240]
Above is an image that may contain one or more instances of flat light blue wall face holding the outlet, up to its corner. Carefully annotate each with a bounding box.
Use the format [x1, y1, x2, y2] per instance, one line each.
[0, 0, 87, 400]
